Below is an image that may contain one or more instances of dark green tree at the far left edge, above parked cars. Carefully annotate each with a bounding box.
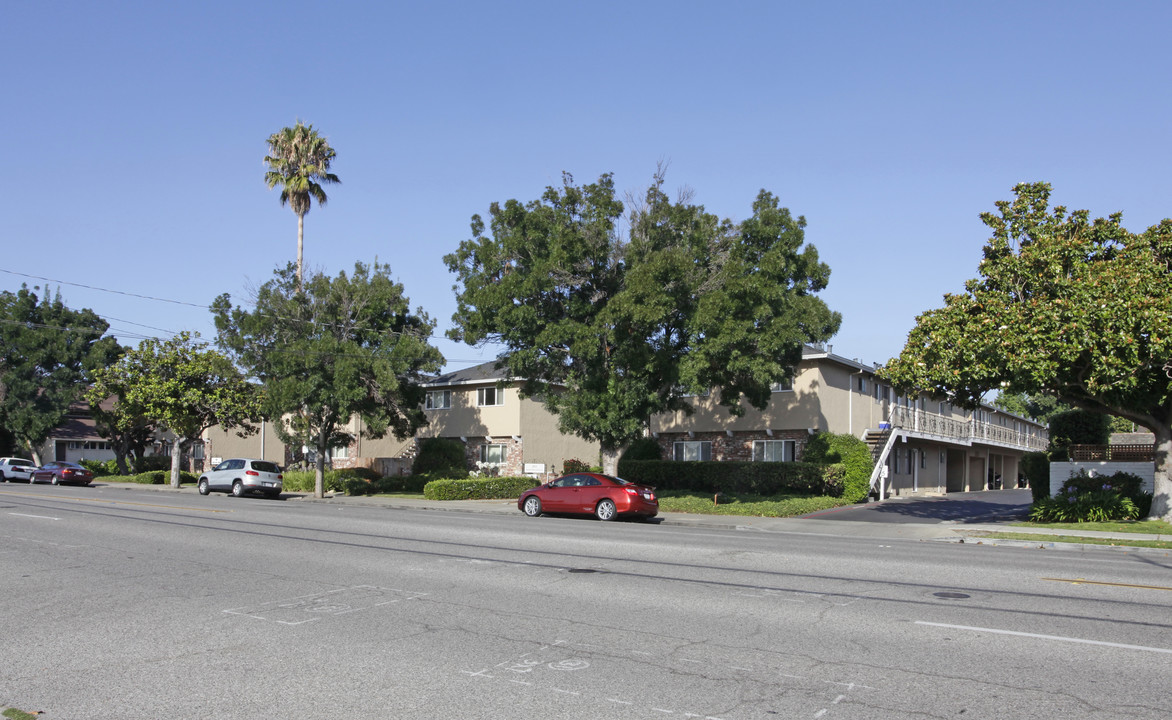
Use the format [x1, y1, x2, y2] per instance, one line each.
[0, 286, 120, 464]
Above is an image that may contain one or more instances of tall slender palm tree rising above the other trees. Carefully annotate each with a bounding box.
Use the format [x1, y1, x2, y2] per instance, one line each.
[265, 120, 342, 288]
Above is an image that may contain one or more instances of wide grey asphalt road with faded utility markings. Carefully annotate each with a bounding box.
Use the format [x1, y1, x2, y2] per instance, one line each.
[0, 485, 1172, 720]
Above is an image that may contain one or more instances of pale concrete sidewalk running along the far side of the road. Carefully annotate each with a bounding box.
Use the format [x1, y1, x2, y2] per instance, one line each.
[84, 478, 1172, 548]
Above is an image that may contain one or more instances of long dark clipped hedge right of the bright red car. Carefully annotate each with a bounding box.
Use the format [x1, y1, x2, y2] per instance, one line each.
[619, 459, 844, 496]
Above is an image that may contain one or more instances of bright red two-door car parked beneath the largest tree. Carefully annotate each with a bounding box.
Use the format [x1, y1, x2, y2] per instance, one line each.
[517, 473, 659, 519]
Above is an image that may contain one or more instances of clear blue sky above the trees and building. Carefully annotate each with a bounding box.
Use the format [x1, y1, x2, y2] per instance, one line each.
[0, 0, 1172, 369]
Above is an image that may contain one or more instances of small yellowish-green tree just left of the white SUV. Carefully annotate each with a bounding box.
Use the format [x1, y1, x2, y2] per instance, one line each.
[112, 333, 260, 488]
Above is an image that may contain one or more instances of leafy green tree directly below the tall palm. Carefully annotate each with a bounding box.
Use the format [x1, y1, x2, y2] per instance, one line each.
[212, 263, 443, 497]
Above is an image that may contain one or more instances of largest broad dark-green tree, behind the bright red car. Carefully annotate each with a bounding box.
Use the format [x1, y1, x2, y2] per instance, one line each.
[444, 171, 840, 473]
